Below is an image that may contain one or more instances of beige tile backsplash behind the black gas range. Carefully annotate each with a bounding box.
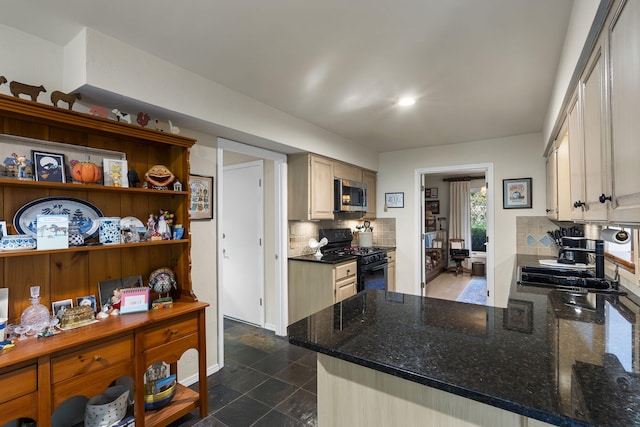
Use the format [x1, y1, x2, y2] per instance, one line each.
[287, 218, 396, 257]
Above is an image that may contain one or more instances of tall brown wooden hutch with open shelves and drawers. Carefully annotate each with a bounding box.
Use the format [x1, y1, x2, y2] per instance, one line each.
[0, 95, 208, 426]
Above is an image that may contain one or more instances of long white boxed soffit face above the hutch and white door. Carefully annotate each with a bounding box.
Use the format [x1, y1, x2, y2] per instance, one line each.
[65, 29, 378, 170]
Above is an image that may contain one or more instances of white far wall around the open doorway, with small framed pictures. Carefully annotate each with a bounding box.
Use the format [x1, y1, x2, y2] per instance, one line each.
[377, 133, 546, 307]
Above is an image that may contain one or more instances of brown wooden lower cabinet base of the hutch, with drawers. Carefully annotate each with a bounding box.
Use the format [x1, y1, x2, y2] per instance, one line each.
[0, 302, 208, 427]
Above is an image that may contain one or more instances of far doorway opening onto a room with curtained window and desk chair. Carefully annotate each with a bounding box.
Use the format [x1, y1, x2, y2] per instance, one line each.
[416, 163, 494, 305]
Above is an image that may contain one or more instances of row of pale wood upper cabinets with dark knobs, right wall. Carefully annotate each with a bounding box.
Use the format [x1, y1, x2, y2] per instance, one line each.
[548, 0, 640, 223]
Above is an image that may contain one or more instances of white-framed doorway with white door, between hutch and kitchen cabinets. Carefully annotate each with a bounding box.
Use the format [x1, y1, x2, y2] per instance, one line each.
[215, 138, 288, 367]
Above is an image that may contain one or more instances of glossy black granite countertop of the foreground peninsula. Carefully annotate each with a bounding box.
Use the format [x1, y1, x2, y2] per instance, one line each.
[288, 256, 640, 426]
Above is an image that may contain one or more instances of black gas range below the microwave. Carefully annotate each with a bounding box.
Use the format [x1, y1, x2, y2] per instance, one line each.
[319, 228, 387, 292]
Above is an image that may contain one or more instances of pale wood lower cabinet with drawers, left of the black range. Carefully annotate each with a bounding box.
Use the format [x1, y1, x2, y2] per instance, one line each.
[289, 259, 358, 324]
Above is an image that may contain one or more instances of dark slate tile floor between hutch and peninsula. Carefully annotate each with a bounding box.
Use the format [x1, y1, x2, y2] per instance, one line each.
[169, 319, 318, 427]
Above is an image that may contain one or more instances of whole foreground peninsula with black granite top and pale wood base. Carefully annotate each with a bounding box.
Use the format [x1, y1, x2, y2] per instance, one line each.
[289, 256, 640, 426]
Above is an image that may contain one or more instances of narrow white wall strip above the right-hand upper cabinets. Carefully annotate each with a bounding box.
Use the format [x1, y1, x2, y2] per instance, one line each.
[542, 0, 600, 148]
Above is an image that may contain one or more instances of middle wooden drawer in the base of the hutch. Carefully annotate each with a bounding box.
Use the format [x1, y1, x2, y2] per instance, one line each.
[51, 335, 133, 384]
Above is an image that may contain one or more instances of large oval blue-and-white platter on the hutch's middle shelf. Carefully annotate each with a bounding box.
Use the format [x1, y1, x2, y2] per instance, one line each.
[13, 197, 103, 239]
